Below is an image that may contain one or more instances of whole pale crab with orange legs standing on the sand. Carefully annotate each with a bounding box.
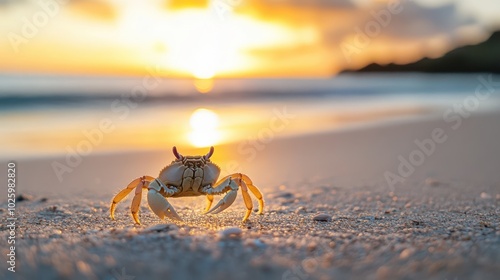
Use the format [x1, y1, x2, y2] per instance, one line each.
[110, 146, 264, 224]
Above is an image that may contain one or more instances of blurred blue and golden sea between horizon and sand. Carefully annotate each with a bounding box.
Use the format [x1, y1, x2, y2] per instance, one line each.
[0, 73, 500, 160]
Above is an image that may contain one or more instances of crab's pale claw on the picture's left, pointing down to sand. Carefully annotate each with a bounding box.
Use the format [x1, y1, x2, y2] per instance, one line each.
[148, 179, 182, 221]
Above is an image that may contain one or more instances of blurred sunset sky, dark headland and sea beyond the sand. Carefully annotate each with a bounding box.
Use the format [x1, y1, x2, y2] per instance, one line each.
[0, 0, 500, 160]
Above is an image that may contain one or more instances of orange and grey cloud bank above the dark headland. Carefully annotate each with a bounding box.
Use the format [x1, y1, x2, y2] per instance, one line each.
[242, 0, 494, 72]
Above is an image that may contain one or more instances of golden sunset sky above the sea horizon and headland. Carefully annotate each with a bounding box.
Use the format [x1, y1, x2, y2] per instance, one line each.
[0, 0, 500, 79]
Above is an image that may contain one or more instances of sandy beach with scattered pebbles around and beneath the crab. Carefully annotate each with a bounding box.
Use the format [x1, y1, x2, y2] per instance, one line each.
[0, 108, 500, 280]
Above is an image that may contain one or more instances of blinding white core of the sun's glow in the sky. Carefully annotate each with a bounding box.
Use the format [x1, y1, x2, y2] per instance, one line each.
[162, 9, 317, 80]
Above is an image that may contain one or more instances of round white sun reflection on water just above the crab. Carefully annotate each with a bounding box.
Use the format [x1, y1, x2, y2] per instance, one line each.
[188, 108, 220, 147]
